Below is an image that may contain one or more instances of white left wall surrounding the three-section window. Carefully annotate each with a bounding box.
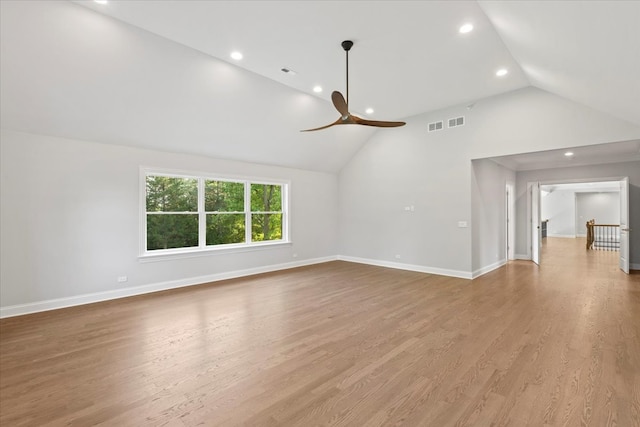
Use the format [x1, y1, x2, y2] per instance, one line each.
[0, 130, 338, 315]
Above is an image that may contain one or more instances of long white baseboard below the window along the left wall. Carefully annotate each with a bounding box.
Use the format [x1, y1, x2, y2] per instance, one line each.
[0, 256, 338, 319]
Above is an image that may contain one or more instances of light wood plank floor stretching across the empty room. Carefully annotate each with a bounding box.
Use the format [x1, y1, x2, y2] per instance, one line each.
[0, 238, 640, 427]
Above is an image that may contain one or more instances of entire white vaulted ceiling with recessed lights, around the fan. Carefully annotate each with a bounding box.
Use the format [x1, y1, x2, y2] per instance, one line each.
[0, 0, 640, 172]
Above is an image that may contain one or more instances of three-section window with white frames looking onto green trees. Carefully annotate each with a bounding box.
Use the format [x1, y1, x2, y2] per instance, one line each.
[141, 171, 288, 255]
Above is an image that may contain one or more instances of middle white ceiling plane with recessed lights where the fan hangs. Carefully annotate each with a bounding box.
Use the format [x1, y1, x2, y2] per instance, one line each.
[71, 1, 529, 120]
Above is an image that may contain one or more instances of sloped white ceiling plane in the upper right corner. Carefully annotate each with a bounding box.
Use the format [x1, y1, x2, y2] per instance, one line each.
[480, 0, 640, 124]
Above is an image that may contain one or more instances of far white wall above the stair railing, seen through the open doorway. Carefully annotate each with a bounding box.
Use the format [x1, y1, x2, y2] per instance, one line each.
[576, 192, 620, 236]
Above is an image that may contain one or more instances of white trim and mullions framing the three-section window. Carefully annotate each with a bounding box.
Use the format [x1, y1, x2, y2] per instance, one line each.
[138, 166, 292, 262]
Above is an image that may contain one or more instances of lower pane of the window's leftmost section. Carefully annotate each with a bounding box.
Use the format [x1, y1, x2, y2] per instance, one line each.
[147, 214, 198, 251]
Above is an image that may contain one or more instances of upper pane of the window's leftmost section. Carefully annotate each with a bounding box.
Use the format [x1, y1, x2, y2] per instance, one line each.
[146, 176, 198, 212]
